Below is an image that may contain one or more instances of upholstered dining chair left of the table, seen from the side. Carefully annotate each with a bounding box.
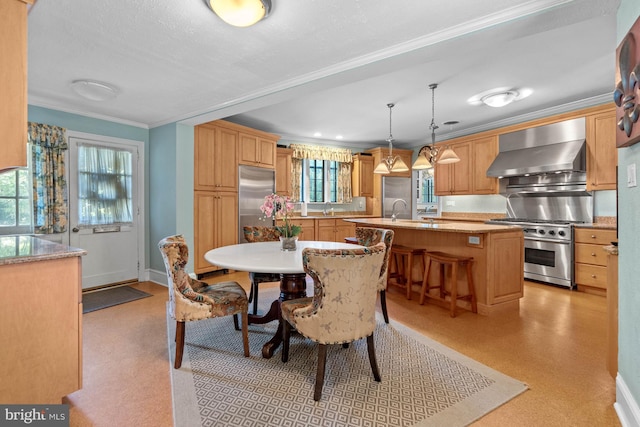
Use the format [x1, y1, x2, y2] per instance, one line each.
[158, 235, 249, 369]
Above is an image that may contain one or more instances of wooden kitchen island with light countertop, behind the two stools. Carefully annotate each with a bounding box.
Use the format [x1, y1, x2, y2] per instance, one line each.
[345, 218, 524, 315]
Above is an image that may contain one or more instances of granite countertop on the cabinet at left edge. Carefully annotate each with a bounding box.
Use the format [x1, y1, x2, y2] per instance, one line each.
[0, 235, 87, 265]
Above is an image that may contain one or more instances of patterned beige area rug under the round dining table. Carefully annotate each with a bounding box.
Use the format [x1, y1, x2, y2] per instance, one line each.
[167, 289, 527, 427]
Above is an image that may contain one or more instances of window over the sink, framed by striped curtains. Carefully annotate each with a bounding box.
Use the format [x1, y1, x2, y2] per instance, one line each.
[300, 159, 338, 203]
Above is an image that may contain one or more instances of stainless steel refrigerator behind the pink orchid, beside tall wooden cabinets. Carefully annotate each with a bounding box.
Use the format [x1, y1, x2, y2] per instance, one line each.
[238, 166, 275, 243]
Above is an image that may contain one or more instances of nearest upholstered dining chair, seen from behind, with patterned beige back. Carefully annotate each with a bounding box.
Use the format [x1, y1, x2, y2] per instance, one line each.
[281, 242, 386, 401]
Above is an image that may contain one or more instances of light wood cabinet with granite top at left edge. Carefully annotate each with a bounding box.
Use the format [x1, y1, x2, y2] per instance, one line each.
[0, 236, 86, 404]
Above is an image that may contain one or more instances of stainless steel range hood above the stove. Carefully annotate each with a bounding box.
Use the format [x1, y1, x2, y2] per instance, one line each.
[487, 117, 586, 178]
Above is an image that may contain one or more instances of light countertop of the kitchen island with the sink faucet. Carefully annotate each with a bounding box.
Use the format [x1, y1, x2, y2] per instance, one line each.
[346, 218, 522, 233]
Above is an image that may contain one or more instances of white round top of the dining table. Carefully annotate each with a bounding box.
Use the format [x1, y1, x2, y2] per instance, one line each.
[204, 241, 362, 274]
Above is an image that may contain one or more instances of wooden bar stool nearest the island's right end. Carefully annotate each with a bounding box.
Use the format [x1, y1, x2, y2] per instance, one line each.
[420, 252, 478, 317]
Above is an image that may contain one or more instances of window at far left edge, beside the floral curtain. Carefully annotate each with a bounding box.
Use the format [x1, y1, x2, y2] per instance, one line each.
[0, 168, 32, 234]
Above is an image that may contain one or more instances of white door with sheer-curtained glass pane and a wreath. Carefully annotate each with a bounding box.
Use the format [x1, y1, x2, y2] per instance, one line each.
[69, 137, 139, 289]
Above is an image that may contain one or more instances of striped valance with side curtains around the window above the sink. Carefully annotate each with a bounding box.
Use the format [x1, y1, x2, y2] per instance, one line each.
[289, 144, 353, 203]
